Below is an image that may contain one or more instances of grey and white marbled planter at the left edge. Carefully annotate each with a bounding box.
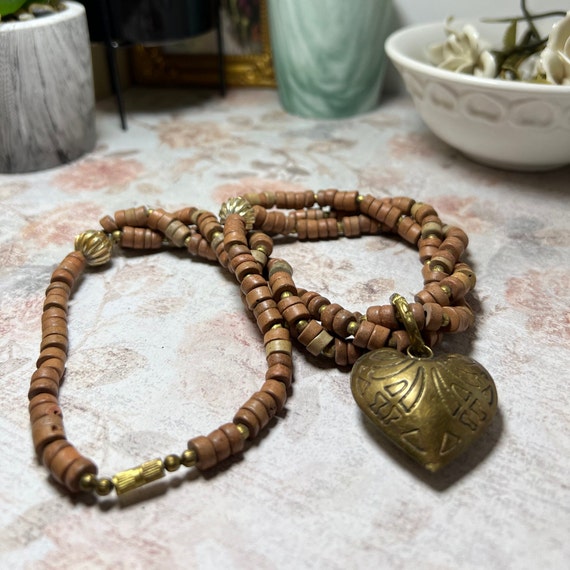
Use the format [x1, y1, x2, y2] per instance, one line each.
[0, 2, 95, 173]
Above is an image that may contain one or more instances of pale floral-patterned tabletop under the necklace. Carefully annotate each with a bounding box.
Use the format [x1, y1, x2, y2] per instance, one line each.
[0, 86, 570, 570]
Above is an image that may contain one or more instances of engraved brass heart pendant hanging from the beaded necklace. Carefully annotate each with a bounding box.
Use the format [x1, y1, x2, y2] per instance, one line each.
[351, 348, 497, 472]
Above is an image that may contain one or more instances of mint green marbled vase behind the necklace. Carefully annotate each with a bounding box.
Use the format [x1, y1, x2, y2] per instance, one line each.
[268, 0, 392, 118]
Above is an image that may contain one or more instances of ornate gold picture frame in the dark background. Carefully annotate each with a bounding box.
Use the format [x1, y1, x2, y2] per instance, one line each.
[132, 0, 276, 87]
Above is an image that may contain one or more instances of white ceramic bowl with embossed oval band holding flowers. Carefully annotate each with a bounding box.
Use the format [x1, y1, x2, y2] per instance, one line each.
[386, 22, 570, 170]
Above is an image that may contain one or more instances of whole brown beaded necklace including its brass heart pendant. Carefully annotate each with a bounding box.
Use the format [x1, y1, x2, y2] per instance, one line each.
[28, 190, 497, 495]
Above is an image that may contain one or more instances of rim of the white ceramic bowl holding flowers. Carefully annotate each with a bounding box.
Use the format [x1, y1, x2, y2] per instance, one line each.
[384, 19, 570, 96]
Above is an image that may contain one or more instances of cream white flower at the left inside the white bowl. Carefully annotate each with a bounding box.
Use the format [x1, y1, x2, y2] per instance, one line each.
[428, 18, 497, 77]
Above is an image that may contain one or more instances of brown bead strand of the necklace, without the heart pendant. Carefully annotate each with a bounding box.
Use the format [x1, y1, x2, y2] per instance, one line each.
[28, 190, 482, 495]
